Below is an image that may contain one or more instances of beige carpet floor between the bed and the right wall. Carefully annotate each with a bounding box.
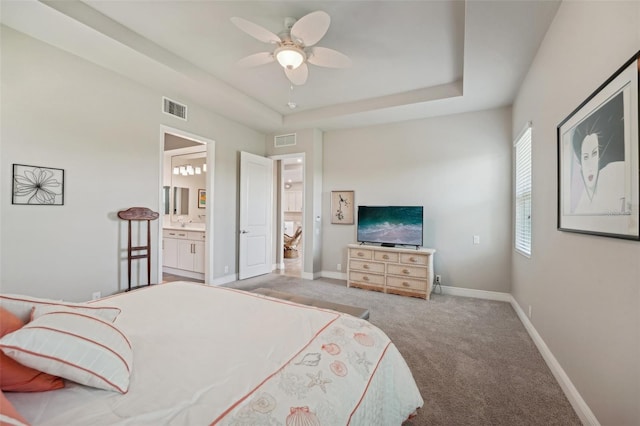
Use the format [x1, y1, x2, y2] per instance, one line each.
[227, 275, 581, 426]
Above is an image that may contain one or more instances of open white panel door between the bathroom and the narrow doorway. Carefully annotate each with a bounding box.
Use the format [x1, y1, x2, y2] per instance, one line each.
[238, 152, 273, 280]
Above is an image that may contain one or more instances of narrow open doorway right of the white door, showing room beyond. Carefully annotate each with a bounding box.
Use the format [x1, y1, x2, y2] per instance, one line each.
[279, 154, 304, 277]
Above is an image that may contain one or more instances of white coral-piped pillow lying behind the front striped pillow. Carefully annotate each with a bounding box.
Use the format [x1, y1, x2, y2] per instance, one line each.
[0, 294, 120, 323]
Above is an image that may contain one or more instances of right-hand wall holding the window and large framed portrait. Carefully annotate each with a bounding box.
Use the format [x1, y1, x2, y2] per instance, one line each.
[512, 1, 640, 425]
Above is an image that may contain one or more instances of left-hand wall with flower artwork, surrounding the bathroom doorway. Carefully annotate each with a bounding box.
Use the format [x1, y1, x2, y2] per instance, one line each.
[0, 26, 264, 300]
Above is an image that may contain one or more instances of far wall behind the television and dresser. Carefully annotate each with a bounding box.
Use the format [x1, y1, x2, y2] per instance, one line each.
[322, 108, 512, 292]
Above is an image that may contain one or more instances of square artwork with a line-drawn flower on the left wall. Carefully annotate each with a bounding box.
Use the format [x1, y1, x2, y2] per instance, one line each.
[11, 163, 64, 206]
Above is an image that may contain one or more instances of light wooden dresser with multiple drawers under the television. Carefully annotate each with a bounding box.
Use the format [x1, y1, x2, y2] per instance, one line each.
[347, 244, 436, 299]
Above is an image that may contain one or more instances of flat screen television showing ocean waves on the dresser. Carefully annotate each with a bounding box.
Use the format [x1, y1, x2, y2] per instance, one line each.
[357, 206, 423, 247]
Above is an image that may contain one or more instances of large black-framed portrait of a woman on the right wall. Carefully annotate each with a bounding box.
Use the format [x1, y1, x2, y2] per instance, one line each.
[557, 52, 640, 240]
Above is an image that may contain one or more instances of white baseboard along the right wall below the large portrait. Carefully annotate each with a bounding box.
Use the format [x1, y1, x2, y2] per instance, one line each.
[509, 295, 600, 426]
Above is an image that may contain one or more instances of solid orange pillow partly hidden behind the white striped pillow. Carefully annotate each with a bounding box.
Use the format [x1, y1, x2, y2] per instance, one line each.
[0, 307, 64, 392]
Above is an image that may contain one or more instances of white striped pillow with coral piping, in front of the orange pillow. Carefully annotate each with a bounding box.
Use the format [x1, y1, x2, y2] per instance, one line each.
[0, 311, 133, 393]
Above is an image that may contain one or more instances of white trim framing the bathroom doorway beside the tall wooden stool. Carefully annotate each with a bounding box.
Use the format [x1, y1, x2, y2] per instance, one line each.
[156, 124, 216, 285]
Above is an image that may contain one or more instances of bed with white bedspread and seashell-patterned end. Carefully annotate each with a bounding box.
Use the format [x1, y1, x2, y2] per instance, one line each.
[0, 282, 423, 426]
